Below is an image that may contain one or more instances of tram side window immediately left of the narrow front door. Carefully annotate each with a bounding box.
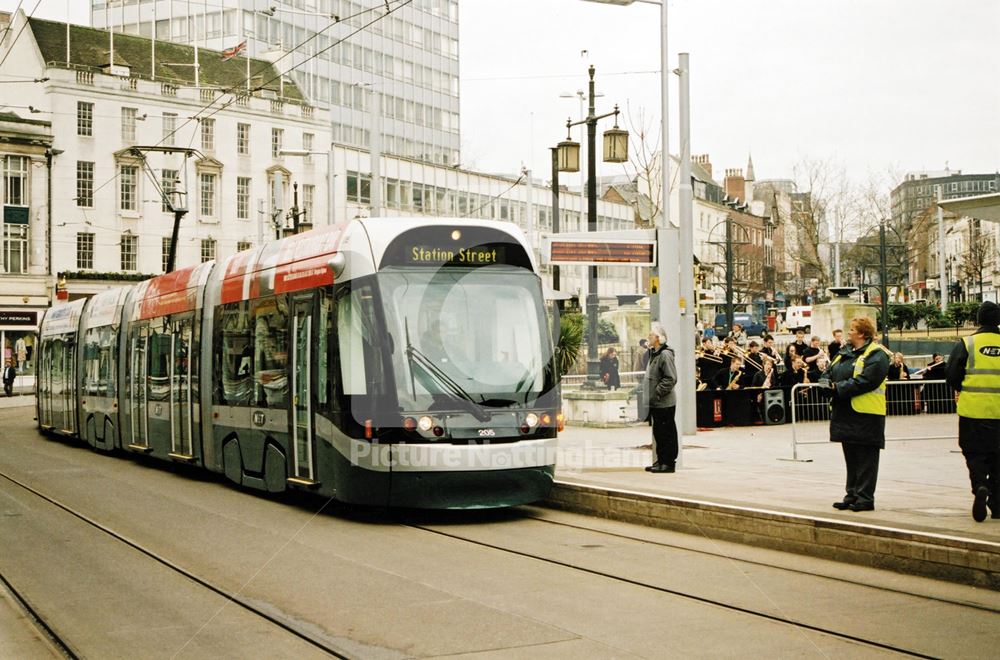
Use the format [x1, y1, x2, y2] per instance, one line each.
[252, 297, 290, 408]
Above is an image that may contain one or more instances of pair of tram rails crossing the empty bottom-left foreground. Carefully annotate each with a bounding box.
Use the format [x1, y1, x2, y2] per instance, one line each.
[0, 472, 355, 659]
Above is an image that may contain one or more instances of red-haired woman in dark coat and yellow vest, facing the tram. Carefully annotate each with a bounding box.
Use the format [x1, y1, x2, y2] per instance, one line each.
[820, 318, 890, 511]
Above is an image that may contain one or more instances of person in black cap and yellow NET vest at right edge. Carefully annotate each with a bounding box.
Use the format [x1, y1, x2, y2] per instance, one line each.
[947, 301, 1000, 522]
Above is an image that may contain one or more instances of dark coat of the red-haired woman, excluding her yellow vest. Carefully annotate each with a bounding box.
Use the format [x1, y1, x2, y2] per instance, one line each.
[823, 344, 889, 449]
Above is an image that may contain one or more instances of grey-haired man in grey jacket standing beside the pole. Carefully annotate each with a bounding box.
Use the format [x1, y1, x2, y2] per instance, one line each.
[643, 325, 677, 472]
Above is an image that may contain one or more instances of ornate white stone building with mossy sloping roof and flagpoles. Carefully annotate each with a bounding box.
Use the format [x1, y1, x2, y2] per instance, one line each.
[0, 12, 329, 298]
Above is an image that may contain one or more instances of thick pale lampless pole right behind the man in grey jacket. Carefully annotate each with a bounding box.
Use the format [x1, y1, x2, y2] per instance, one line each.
[664, 52, 698, 444]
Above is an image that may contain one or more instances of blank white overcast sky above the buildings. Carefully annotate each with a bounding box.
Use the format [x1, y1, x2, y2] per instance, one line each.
[0, 0, 1000, 183]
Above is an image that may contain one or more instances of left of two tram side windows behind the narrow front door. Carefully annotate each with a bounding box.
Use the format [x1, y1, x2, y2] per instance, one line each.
[215, 301, 255, 406]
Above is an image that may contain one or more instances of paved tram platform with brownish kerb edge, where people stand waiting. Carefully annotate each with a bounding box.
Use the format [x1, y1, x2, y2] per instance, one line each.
[548, 415, 1000, 589]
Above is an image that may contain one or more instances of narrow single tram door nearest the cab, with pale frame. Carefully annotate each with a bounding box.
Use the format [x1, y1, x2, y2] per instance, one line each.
[292, 298, 314, 481]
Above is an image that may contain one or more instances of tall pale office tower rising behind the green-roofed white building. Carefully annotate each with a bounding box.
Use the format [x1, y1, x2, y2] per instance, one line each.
[91, 0, 461, 165]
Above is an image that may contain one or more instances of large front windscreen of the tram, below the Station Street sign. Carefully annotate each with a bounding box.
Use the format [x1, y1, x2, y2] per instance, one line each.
[378, 265, 552, 410]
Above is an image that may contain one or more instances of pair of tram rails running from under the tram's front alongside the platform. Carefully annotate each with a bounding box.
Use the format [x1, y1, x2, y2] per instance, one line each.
[400, 515, 984, 658]
